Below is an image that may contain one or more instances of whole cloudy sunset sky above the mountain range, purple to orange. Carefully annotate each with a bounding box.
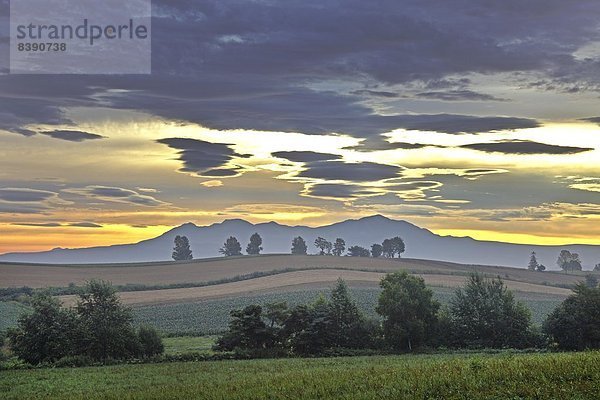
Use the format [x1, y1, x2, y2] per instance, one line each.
[0, 0, 600, 253]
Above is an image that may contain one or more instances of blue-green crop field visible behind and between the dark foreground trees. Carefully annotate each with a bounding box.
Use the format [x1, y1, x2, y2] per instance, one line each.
[133, 287, 564, 335]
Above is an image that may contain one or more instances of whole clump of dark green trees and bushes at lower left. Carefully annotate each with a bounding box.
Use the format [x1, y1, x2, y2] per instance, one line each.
[8, 281, 163, 365]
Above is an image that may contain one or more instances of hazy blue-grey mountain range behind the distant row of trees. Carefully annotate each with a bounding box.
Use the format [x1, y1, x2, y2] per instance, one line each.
[0, 215, 600, 269]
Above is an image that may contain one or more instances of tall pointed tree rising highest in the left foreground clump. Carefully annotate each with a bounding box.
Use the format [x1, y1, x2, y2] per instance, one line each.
[75, 281, 141, 360]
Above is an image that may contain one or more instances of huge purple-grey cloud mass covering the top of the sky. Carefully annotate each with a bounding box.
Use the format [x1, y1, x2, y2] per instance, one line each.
[0, 0, 600, 137]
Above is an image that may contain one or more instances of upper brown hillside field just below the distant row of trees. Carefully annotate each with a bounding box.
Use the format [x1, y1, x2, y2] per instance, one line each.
[0, 255, 583, 287]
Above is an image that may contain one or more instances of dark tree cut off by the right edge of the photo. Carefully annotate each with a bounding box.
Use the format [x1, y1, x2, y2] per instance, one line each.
[544, 283, 600, 350]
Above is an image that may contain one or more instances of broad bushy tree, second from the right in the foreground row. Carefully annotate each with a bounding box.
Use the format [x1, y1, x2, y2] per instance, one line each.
[450, 274, 532, 348]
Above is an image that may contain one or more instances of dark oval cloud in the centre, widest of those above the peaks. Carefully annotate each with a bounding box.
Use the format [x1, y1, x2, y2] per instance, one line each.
[297, 161, 404, 182]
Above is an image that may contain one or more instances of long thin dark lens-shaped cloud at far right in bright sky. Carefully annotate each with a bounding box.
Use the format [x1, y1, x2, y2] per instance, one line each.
[460, 140, 594, 155]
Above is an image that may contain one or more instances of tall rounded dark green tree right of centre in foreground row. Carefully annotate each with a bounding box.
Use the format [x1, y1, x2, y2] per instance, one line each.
[376, 271, 440, 351]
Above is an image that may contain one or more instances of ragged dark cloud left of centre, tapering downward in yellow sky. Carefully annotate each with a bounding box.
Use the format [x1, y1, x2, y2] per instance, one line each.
[157, 138, 247, 176]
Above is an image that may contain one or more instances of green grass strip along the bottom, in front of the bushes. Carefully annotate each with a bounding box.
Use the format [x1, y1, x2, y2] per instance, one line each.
[0, 352, 600, 400]
